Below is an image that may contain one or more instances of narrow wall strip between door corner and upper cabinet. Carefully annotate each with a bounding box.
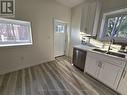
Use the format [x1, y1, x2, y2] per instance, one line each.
[69, 4, 81, 57]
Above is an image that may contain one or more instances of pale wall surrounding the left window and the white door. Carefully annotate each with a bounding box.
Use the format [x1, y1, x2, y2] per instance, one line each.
[0, 0, 71, 74]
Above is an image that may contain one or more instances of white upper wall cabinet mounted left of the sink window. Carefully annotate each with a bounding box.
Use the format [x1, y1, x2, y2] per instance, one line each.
[80, 0, 100, 36]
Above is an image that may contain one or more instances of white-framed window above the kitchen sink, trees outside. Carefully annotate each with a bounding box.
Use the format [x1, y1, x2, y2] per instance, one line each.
[99, 8, 127, 44]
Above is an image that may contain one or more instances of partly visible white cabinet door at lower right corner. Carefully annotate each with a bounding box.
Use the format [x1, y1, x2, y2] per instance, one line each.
[117, 71, 127, 95]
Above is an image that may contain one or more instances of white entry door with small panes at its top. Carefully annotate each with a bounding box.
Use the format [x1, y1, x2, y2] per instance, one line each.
[54, 20, 67, 57]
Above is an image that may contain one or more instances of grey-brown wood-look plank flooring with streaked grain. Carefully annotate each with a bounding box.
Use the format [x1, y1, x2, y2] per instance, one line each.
[0, 57, 117, 95]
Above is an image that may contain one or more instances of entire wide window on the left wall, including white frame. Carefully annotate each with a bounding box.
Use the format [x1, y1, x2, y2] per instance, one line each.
[0, 18, 32, 47]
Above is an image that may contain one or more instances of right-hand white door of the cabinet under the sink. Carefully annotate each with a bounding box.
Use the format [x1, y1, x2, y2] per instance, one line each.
[98, 61, 122, 90]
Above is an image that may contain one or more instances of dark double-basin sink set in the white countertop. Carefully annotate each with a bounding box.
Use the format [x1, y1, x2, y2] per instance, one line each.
[92, 48, 126, 58]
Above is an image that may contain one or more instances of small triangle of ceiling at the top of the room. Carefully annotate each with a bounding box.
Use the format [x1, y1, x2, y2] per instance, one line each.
[56, 0, 85, 8]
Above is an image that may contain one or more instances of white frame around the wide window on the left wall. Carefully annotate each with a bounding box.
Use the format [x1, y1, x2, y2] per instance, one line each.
[0, 18, 33, 47]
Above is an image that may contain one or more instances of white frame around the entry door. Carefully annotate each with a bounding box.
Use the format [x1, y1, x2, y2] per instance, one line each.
[53, 18, 71, 59]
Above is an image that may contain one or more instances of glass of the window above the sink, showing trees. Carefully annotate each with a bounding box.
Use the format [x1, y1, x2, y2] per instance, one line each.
[105, 15, 127, 38]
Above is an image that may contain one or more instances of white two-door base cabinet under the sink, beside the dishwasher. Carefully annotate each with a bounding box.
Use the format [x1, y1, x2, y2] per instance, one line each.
[85, 52, 125, 90]
